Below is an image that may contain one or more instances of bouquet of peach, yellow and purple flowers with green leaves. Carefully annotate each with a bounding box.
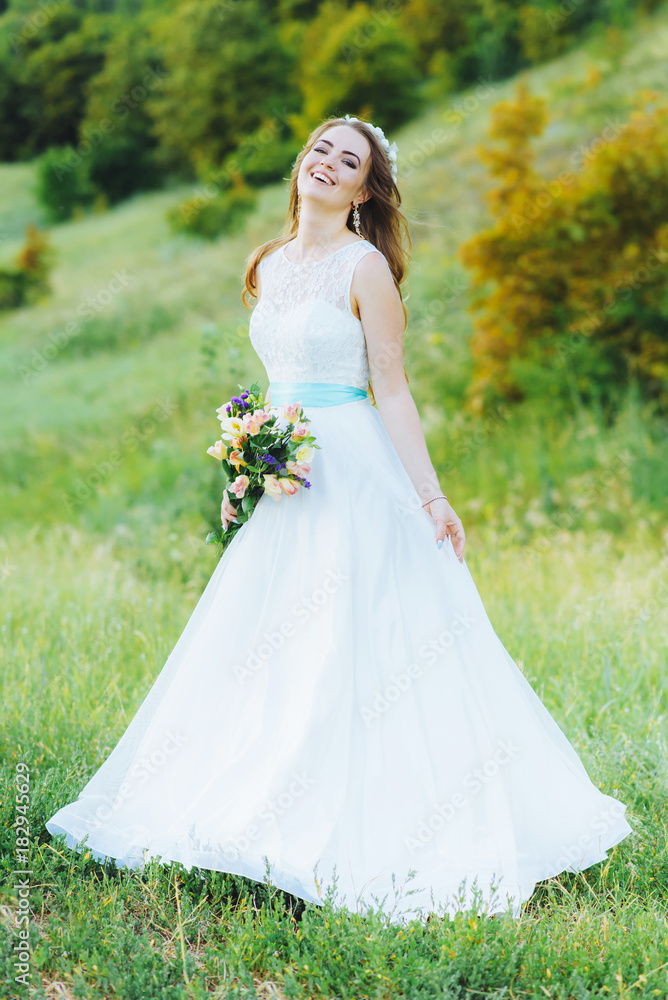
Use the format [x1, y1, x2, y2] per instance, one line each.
[206, 382, 320, 554]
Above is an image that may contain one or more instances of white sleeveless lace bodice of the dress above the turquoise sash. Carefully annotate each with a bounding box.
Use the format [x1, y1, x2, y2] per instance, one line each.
[250, 240, 380, 390]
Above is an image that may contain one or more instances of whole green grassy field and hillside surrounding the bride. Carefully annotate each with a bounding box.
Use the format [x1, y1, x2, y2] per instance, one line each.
[0, 8, 668, 1000]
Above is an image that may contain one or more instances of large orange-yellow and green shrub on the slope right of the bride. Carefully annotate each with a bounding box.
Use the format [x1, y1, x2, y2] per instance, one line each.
[459, 86, 668, 409]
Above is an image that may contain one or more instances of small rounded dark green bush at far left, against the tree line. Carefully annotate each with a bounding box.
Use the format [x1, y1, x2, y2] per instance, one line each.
[35, 145, 100, 222]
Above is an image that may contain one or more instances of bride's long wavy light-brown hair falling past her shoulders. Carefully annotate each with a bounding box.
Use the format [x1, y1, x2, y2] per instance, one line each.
[241, 118, 411, 402]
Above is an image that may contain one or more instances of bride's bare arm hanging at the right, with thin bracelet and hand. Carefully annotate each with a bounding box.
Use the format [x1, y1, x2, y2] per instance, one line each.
[351, 253, 465, 558]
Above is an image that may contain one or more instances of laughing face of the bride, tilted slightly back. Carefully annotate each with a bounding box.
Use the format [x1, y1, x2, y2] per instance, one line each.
[297, 125, 371, 208]
